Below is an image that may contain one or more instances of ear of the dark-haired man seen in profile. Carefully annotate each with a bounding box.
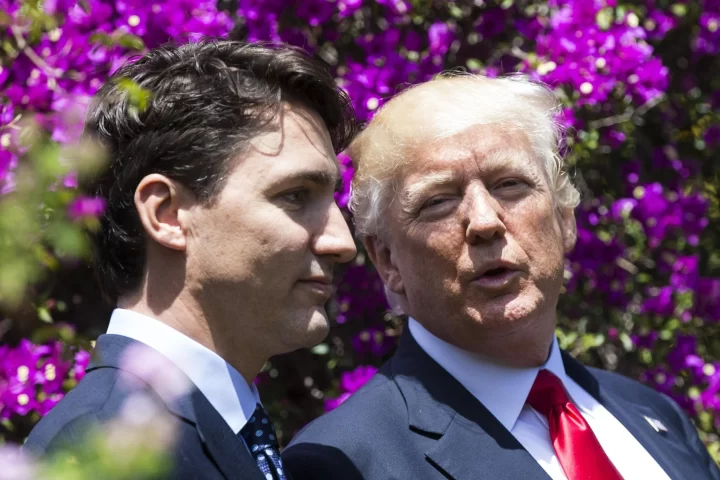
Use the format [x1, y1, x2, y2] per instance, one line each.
[135, 173, 189, 251]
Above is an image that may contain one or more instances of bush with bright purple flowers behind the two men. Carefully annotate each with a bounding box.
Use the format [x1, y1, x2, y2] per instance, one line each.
[0, 0, 720, 458]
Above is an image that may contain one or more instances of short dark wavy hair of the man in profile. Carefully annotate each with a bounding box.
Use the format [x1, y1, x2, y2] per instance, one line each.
[85, 40, 357, 302]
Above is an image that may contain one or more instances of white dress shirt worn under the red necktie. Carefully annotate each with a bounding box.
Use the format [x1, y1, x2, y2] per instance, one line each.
[408, 318, 669, 480]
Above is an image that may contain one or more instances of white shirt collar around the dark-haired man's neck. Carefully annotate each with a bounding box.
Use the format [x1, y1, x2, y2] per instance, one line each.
[107, 308, 260, 433]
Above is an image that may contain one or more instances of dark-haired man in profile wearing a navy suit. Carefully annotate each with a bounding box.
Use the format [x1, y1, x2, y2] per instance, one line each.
[26, 41, 356, 480]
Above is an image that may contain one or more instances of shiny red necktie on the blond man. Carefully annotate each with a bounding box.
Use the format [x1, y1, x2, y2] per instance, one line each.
[527, 370, 622, 480]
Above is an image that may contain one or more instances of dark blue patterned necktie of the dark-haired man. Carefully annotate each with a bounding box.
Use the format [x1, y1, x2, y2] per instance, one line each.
[238, 403, 287, 480]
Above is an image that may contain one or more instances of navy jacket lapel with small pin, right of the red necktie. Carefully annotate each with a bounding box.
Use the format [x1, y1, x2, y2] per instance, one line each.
[563, 352, 694, 480]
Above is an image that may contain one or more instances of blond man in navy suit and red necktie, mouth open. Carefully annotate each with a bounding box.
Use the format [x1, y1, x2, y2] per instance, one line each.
[284, 75, 720, 480]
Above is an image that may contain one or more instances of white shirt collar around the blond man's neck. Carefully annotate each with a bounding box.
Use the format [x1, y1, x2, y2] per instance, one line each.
[408, 317, 567, 431]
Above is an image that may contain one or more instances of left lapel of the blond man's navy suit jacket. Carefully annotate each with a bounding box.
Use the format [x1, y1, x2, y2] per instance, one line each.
[391, 329, 549, 480]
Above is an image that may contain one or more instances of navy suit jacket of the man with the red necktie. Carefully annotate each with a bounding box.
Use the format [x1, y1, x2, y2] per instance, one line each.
[283, 331, 720, 480]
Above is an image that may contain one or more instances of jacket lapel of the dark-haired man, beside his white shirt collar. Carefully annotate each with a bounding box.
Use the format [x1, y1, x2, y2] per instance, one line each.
[87, 335, 265, 480]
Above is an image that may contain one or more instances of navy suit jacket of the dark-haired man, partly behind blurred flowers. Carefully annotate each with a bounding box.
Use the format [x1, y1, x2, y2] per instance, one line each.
[25, 335, 264, 480]
